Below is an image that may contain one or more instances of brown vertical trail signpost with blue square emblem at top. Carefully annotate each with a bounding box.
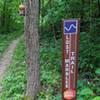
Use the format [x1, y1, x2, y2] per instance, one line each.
[62, 19, 79, 100]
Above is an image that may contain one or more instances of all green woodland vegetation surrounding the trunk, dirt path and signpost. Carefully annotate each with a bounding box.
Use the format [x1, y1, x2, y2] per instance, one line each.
[0, 0, 100, 100]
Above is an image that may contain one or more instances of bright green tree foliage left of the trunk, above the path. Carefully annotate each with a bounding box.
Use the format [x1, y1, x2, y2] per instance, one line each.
[0, 0, 23, 34]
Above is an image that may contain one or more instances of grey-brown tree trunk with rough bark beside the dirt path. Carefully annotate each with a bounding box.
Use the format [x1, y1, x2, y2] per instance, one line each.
[25, 0, 40, 100]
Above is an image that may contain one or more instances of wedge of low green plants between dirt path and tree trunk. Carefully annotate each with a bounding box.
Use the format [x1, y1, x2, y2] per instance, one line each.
[0, 41, 26, 100]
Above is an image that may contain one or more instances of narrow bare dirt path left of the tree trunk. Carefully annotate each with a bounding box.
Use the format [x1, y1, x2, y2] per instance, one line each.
[0, 38, 20, 92]
